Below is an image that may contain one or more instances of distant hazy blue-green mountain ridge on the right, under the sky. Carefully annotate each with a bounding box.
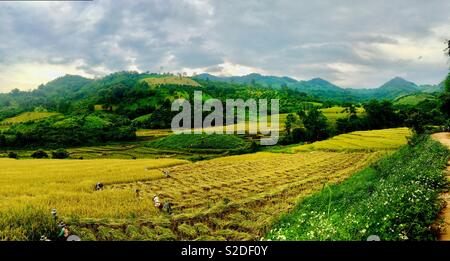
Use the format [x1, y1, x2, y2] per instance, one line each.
[193, 73, 444, 101]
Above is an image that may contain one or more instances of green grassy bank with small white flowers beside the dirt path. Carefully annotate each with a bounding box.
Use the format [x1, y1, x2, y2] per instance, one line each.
[266, 138, 450, 241]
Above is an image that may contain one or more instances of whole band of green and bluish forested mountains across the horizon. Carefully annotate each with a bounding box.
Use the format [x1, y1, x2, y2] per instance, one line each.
[0, 72, 443, 119]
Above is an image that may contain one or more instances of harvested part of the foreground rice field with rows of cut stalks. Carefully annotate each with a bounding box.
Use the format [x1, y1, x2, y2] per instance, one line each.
[84, 152, 382, 240]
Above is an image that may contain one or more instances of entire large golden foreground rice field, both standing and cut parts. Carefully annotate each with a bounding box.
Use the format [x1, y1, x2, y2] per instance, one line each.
[0, 148, 383, 240]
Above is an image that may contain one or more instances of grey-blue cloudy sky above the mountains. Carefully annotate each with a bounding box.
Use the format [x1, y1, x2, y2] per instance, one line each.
[0, 0, 450, 92]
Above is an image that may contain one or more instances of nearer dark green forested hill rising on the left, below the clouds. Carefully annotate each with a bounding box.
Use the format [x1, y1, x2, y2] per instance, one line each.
[0, 72, 317, 122]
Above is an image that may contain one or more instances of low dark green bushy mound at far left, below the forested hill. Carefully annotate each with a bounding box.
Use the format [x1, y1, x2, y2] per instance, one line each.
[0, 112, 136, 148]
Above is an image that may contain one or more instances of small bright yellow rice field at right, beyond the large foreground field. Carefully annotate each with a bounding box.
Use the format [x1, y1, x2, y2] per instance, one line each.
[291, 128, 412, 152]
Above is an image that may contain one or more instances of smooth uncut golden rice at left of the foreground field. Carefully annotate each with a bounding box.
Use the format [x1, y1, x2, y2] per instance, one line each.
[0, 159, 187, 218]
